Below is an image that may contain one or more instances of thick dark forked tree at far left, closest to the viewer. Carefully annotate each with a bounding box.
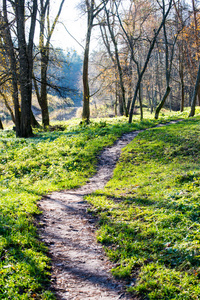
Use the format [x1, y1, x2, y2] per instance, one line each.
[1, 0, 37, 137]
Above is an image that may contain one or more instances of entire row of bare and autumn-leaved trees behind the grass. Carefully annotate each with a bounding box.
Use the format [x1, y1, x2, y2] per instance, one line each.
[0, 0, 200, 137]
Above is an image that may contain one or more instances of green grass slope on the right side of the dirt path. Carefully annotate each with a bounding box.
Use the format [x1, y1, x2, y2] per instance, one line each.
[87, 117, 200, 300]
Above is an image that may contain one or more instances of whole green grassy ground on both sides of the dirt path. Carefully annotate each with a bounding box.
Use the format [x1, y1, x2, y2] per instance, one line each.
[0, 110, 200, 299]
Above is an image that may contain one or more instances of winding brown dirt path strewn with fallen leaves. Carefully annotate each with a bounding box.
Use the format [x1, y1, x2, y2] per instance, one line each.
[39, 120, 182, 300]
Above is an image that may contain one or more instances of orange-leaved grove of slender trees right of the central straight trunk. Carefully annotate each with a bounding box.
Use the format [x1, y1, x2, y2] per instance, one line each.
[88, 0, 200, 118]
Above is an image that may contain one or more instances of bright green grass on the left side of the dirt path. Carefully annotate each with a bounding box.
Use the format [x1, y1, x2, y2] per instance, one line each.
[0, 109, 199, 300]
